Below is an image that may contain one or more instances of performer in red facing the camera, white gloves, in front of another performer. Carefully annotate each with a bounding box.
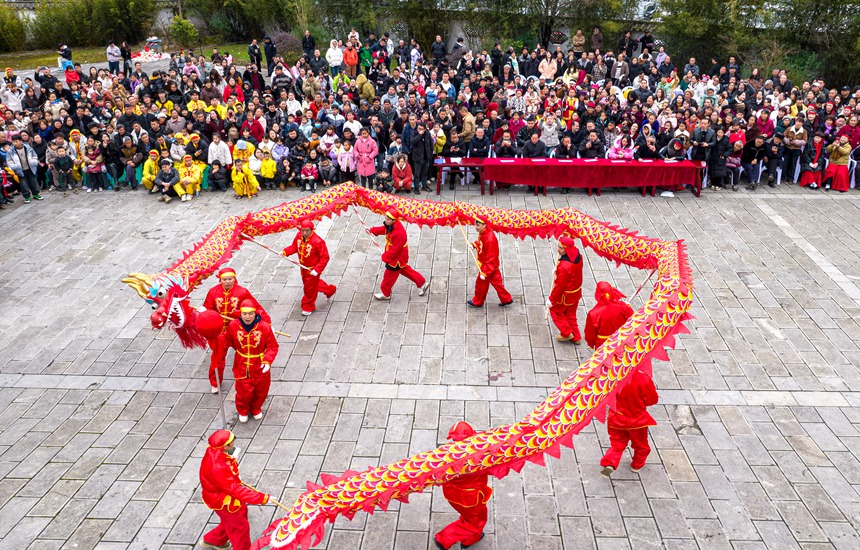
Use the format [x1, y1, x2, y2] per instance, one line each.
[225, 300, 278, 422]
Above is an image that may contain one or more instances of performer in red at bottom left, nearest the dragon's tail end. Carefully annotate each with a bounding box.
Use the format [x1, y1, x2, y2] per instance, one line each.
[200, 430, 269, 550]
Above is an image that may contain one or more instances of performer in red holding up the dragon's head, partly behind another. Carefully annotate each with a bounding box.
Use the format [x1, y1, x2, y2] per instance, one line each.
[198, 267, 272, 393]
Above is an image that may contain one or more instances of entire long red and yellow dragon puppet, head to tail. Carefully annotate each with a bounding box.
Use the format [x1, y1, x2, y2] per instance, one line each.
[123, 184, 693, 550]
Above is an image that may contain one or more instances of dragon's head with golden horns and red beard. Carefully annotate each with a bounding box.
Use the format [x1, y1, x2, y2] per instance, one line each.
[122, 273, 206, 348]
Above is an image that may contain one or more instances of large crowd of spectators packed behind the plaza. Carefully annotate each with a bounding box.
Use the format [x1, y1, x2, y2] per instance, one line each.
[0, 28, 860, 209]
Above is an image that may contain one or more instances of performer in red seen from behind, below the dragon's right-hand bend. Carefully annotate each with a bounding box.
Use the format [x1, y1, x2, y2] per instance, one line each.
[600, 369, 659, 477]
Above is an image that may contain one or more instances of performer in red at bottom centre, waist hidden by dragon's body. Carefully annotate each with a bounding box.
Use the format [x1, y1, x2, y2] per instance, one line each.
[435, 422, 493, 550]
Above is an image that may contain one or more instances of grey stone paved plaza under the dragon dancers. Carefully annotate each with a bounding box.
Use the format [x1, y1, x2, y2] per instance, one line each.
[0, 182, 860, 550]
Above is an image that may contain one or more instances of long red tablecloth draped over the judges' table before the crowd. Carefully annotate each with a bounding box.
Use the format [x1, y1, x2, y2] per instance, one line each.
[484, 158, 703, 195]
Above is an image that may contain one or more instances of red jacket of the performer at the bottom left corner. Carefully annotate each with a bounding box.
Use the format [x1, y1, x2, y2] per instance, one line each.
[200, 447, 269, 513]
